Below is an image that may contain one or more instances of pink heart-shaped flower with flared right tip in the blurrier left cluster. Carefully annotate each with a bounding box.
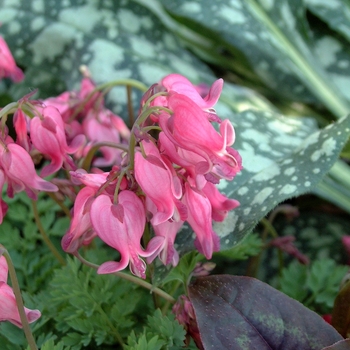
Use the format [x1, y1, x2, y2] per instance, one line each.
[30, 106, 85, 176]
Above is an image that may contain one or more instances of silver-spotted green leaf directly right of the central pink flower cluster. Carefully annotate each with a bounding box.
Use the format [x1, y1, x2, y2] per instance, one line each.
[176, 108, 350, 251]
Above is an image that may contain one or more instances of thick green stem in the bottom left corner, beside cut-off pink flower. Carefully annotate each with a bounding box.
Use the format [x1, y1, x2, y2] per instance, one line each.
[0, 245, 38, 350]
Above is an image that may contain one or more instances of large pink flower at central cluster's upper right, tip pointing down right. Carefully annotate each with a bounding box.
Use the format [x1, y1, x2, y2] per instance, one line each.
[159, 94, 242, 180]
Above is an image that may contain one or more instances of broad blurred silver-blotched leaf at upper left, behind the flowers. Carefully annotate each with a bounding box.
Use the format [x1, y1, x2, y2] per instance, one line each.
[0, 0, 274, 113]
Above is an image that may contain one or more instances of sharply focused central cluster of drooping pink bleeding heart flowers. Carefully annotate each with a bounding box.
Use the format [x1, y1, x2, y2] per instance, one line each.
[62, 74, 241, 278]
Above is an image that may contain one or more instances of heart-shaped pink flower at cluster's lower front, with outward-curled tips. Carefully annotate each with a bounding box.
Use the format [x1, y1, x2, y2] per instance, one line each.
[90, 190, 159, 278]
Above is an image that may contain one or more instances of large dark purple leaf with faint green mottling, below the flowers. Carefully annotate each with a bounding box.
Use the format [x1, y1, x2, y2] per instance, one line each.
[189, 275, 343, 350]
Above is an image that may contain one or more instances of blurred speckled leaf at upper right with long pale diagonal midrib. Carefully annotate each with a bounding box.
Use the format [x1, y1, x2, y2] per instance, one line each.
[162, 0, 350, 117]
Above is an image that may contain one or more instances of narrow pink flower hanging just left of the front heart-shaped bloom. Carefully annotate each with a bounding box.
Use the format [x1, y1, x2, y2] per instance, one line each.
[61, 186, 97, 253]
